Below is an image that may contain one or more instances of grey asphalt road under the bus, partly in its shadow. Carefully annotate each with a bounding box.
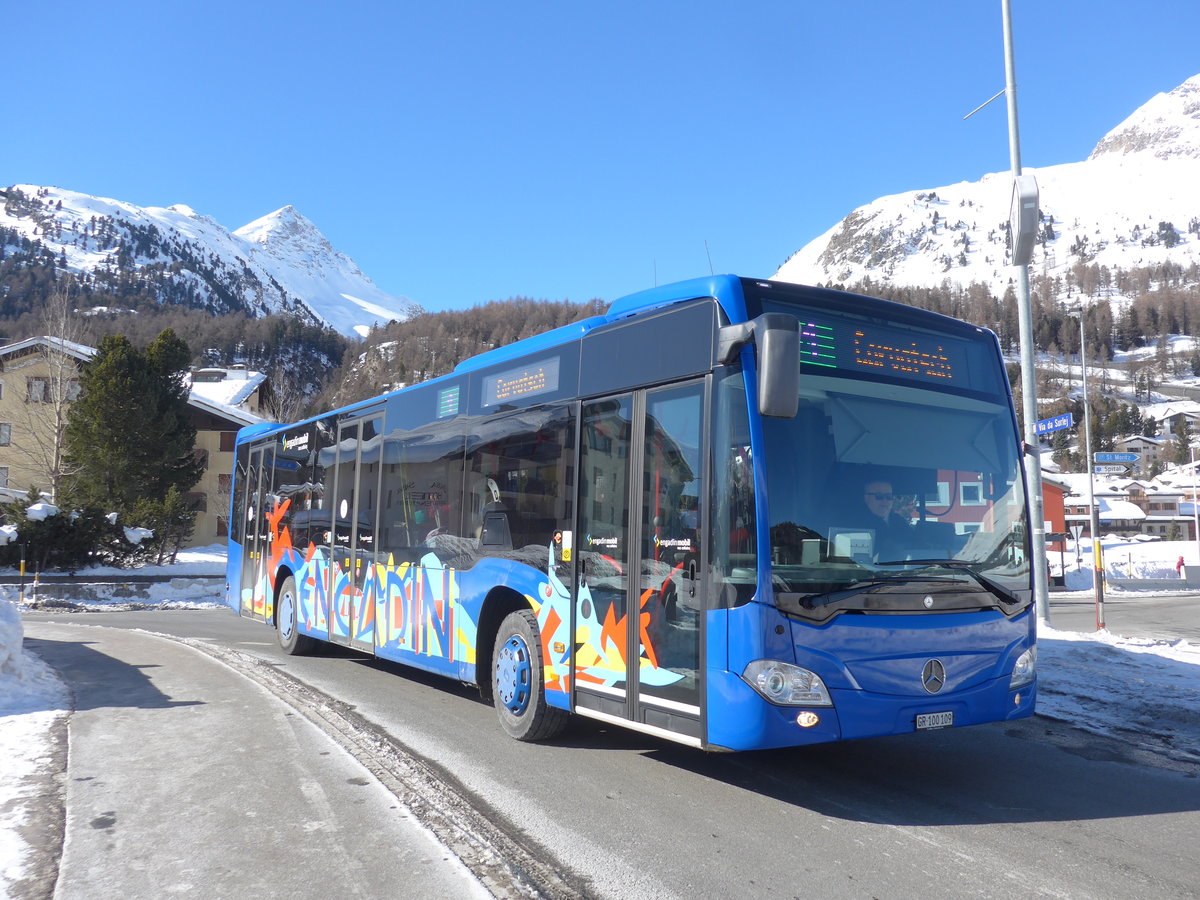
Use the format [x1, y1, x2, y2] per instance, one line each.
[28, 607, 1200, 900]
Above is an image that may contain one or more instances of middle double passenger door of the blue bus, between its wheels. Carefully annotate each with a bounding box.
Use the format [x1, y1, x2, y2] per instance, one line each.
[329, 415, 383, 653]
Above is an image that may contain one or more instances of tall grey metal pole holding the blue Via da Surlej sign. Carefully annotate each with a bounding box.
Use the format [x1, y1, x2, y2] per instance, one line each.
[1001, 0, 1050, 625]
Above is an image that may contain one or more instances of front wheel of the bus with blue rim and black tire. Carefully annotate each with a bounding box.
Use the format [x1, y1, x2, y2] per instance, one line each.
[492, 610, 568, 742]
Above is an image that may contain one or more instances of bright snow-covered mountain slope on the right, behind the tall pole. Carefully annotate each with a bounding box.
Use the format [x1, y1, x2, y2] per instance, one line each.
[773, 76, 1200, 294]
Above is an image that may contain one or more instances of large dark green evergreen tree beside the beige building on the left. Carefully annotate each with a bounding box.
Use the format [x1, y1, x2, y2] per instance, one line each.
[66, 329, 203, 512]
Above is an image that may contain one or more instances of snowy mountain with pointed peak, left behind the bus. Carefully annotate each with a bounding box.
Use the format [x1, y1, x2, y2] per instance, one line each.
[0, 185, 420, 336]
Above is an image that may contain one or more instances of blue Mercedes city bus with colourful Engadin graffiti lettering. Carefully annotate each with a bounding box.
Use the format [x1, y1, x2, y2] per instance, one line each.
[227, 276, 1037, 751]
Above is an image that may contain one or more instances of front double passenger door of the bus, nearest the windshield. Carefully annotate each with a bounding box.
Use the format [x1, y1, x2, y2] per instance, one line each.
[572, 382, 704, 744]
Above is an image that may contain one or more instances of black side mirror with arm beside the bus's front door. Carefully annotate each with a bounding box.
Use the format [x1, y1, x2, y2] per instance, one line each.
[716, 312, 800, 419]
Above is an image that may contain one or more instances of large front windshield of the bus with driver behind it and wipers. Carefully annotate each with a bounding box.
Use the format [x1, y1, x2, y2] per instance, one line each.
[763, 371, 1030, 620]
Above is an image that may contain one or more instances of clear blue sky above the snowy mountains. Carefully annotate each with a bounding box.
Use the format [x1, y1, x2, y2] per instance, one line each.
[9, 0, 1200, 310]
